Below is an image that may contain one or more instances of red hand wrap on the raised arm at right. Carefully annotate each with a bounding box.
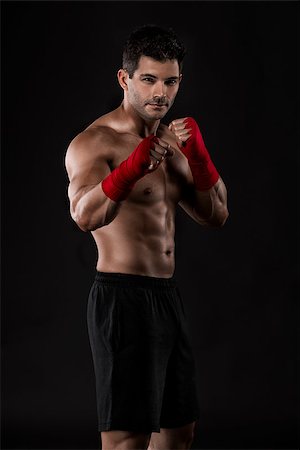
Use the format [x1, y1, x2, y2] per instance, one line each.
[180, 117, 219, 191]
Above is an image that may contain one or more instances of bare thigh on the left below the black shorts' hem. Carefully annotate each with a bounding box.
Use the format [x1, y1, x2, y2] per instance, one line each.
[101, 430, 150, 450]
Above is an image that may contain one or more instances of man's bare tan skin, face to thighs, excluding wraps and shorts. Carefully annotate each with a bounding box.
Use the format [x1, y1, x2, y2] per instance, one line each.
[66, 56, 228, 450]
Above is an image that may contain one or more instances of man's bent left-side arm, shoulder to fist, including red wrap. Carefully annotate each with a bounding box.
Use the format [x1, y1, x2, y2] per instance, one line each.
[66, 128, 173, 231]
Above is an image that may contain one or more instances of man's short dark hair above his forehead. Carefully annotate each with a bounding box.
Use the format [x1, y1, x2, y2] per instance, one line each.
[123, 25, 186, 78]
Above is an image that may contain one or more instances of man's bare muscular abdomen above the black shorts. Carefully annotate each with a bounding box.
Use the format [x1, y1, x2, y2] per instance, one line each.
[92, 201, 175, 278]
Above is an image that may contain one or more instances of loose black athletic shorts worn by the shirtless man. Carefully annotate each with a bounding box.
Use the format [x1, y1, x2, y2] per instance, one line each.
[87, 272, 198, 433]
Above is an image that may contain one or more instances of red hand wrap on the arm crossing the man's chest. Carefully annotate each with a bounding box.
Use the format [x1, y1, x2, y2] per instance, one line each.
[102, 134, 158, 202]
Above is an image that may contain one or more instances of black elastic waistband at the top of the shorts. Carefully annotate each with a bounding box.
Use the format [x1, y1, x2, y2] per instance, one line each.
[95, 272, 176, 289]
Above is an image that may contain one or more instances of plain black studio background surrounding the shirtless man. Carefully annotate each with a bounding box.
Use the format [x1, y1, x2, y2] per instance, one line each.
[1, 1, 299, 449]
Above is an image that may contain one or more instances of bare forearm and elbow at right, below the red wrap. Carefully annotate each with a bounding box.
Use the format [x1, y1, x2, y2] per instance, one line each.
[193, 178, 228, 227]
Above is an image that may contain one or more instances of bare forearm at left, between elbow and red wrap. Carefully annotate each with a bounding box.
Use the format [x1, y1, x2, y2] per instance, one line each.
[71, 183, 121, 231]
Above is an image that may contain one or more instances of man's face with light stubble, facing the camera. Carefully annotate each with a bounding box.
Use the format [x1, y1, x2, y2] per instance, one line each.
[127, 56, 181, 120]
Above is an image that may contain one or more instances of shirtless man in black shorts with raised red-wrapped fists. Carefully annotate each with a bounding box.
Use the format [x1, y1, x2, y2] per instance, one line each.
[66, 26, 228, 450]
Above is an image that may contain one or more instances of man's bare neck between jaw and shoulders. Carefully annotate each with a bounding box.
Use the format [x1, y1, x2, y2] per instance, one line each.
[119, 99, 160, 138]
